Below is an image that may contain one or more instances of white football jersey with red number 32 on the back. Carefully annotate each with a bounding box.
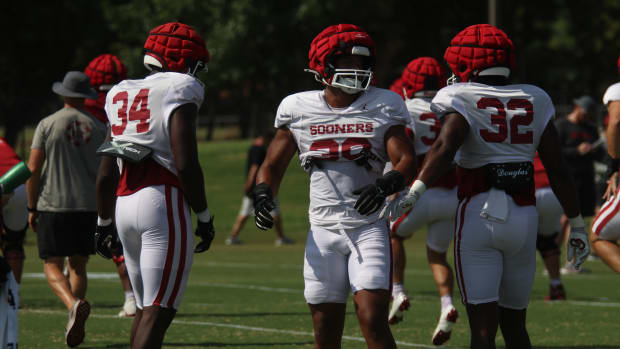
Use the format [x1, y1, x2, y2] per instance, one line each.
[431, 83, 555, 169]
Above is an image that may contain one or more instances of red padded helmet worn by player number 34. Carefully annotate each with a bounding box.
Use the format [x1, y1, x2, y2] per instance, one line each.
[144, 22, 210, 75]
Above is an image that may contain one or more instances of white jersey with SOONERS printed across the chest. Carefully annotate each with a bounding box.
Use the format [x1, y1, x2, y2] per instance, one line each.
[275, 87, 409, 229]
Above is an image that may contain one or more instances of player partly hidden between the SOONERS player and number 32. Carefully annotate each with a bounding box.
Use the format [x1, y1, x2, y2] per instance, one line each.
[388, 57, 458, 345]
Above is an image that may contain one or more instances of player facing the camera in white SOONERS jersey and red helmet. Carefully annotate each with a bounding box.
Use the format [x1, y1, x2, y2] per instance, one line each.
[254, 24, 416, 348]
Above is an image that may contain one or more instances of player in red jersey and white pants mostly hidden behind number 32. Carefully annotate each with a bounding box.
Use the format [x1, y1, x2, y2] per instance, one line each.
[534, 153, 566, 301]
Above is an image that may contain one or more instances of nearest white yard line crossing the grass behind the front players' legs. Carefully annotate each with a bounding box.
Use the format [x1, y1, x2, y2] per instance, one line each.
[20, 309, 441, 348]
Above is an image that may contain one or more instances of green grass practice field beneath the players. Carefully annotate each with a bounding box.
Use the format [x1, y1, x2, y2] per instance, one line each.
[19, 141, 620, 349]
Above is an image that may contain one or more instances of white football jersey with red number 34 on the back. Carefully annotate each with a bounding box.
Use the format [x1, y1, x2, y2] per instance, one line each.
[105, 72, 204, 175]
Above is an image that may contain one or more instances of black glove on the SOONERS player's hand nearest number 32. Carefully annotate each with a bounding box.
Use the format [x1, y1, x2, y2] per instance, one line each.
[353, 171, 405, 216]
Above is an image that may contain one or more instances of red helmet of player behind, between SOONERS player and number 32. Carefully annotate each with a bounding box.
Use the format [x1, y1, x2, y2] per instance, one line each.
[401, 57, 446, 99]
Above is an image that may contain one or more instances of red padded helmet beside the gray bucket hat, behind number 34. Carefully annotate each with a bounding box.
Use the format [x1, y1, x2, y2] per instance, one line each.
[84, 53, 127, 91]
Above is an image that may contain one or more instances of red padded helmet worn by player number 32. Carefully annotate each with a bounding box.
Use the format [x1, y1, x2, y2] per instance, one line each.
[443, 24, 515, 82]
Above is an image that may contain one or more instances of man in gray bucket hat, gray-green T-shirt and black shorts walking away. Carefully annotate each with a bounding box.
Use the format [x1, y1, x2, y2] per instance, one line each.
[26, 71, 106, 347]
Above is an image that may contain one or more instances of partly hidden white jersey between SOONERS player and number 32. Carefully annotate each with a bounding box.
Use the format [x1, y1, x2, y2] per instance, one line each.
[405, 98, 441, 155]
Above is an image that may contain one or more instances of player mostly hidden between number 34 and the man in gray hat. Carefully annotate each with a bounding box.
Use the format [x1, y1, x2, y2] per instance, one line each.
[84, 53, 136, 317]
